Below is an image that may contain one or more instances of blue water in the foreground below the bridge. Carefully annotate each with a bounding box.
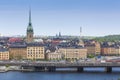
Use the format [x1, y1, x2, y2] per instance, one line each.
[0, 68, 120, 80]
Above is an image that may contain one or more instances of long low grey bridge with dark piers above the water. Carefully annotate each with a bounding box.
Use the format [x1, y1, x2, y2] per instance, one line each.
[0, 62, 120, 72]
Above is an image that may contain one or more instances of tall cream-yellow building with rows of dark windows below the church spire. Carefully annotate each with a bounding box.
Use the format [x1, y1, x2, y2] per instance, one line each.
[27, 43, 45, 60]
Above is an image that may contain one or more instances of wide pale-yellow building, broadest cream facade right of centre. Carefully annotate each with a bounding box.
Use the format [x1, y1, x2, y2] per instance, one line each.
[59, 47, 87, 59]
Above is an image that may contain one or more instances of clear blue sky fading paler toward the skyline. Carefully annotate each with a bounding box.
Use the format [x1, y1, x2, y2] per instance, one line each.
[0, 0, 120, 36]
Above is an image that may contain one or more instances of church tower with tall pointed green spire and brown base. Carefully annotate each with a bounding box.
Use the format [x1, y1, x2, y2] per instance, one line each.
[26, 9, 34, 43]
